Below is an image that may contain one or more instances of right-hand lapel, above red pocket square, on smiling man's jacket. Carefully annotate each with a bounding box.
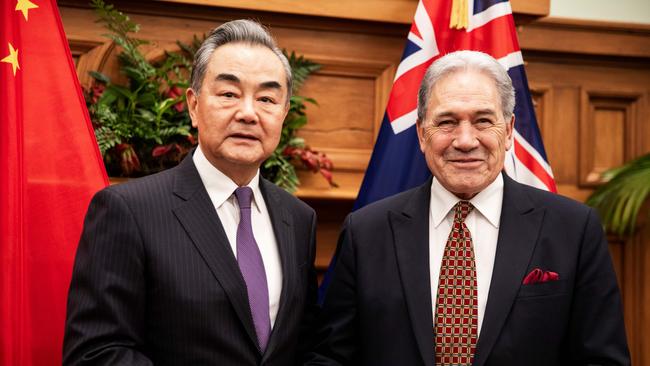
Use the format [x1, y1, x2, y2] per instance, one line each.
[474, 174, 544, 366]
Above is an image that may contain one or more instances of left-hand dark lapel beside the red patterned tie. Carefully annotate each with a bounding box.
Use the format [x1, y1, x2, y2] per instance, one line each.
[388, 179, 435, 366]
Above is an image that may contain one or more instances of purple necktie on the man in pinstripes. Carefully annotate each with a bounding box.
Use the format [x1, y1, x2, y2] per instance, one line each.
[235, 187, 271, 352]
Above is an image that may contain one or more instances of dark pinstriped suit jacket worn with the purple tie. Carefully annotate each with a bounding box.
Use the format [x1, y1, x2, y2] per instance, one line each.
[64, 156, 316, 365]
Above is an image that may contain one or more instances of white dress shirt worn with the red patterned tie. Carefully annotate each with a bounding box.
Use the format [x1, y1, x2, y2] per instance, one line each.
[429, 174, 503, 335]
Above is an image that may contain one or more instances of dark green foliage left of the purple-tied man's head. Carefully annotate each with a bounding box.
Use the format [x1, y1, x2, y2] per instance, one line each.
[88, 0, 196, 176]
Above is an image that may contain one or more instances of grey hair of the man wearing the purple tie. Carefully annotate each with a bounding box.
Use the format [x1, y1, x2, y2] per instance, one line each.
[190, 19, 293, 103]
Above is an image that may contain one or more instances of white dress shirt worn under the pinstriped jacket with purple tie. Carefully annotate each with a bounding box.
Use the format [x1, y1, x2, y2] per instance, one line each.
[193, 146, 282, 327]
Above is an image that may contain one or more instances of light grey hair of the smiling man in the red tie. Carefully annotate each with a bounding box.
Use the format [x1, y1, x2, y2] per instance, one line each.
[418, 51, 515, 123]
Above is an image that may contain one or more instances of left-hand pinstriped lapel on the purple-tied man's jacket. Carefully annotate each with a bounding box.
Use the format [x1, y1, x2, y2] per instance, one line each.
[173, 154, 258, 347]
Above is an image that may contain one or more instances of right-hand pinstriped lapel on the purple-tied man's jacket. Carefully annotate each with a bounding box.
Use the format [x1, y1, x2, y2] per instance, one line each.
[260, 178, 297, 363]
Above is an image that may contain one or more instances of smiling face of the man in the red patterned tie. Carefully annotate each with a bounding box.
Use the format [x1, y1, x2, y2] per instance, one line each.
[417, 70, 514, 199]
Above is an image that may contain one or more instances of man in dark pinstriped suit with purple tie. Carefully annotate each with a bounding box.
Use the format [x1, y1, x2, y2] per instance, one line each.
[64, 20, 316, 365]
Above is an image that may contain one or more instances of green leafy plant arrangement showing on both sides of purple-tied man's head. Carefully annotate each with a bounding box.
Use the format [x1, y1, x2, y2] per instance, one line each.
[85, 0, 335, 192]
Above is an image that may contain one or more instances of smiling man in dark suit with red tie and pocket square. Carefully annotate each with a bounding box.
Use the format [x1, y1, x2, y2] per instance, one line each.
[306, 51, 630, 366]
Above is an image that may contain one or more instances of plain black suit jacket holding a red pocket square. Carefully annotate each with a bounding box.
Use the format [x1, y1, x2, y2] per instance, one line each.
[307, 174, 630, 366]
